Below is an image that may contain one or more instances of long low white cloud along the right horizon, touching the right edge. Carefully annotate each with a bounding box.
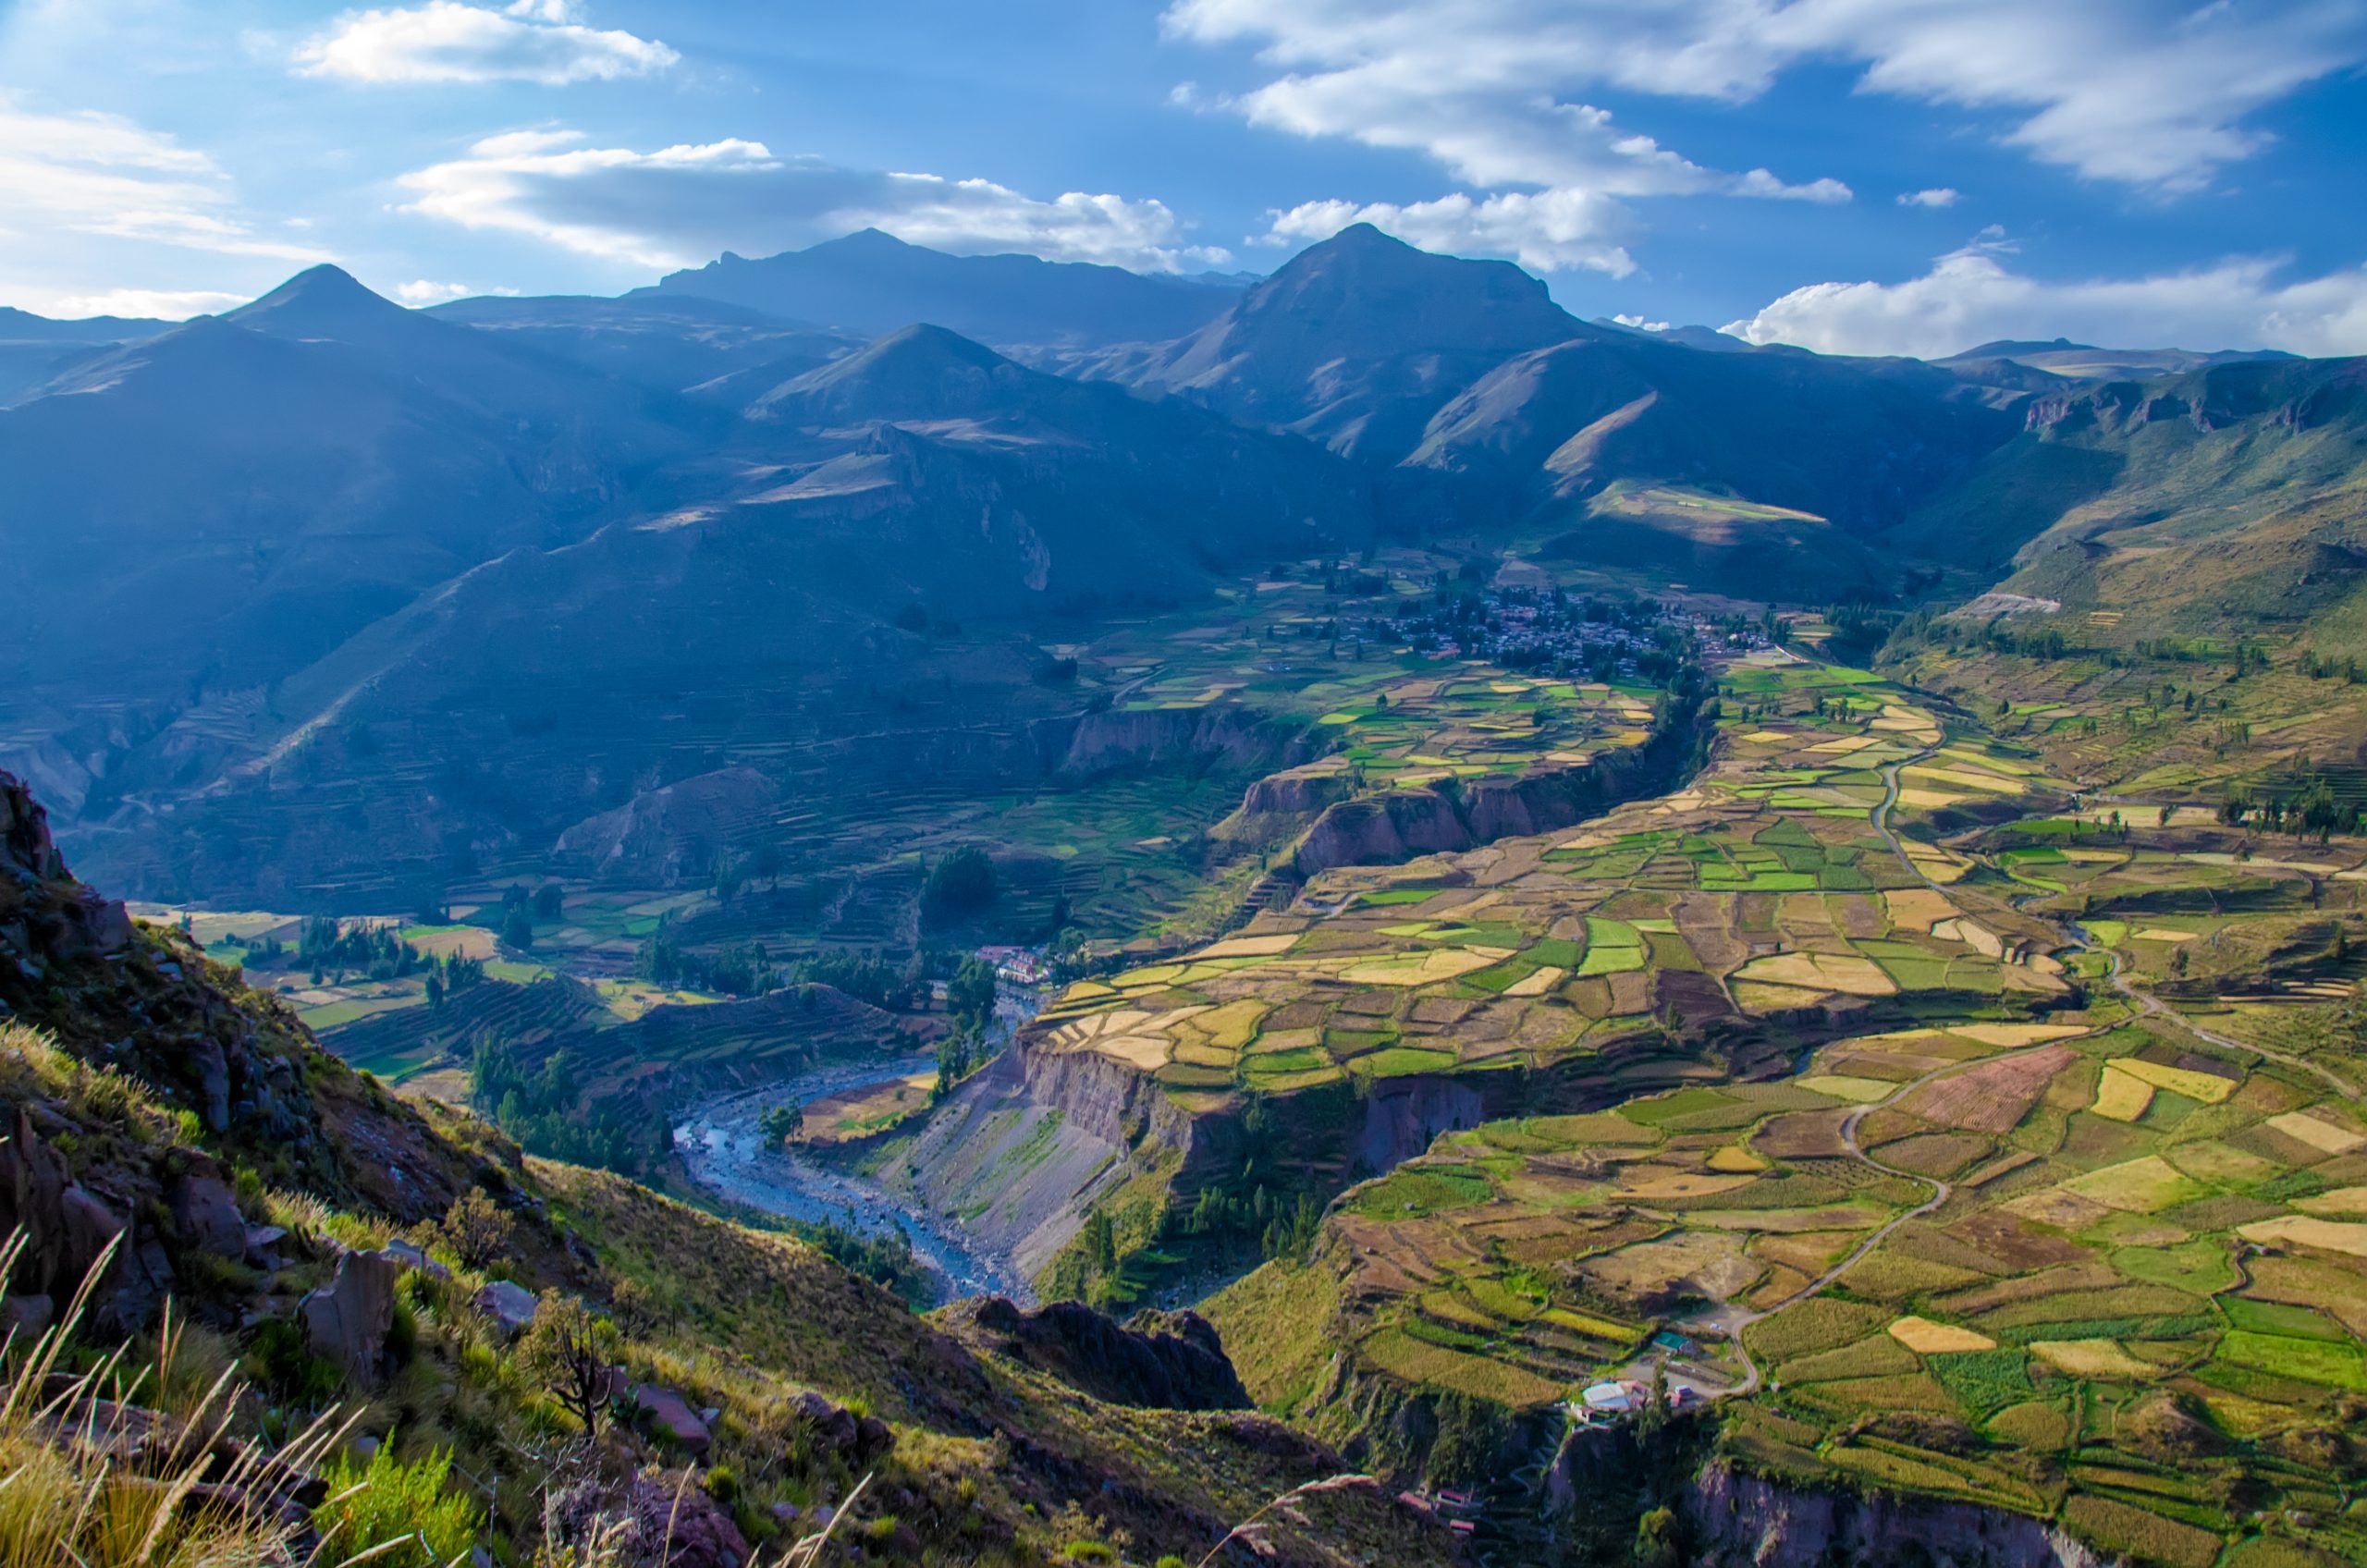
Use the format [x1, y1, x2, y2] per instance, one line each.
[1725, 244, 2367, 358]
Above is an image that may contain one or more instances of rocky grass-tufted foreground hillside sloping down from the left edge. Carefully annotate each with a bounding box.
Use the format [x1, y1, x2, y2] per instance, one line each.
[0, 779, 1446, 1568]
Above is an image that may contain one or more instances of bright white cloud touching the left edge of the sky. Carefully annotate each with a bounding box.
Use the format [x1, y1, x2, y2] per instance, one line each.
[0, 94, 326, 263]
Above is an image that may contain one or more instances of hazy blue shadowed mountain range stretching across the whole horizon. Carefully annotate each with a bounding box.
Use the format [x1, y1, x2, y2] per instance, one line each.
[0, 225, 2367, 895]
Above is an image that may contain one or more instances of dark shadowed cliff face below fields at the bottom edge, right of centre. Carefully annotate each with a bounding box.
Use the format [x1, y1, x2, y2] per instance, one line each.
[1686, 1464, 2106, 1568]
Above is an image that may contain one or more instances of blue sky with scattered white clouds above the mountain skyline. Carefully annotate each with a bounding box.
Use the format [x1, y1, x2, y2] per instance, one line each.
[0, 0, 2367, 353]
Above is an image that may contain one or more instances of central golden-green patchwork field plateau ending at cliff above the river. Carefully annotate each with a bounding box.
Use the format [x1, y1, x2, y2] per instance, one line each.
[1030, 661, 2067, 1111]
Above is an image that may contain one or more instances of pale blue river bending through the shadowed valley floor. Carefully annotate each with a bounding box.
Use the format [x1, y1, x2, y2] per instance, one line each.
[675, 1057, 1035, 1305]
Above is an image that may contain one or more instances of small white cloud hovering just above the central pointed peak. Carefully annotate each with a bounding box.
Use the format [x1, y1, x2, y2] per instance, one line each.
[1252, 190, 1636, 277]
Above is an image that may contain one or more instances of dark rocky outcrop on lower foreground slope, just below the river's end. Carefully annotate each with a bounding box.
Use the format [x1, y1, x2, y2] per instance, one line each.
[950, 1295, 1250, 1409]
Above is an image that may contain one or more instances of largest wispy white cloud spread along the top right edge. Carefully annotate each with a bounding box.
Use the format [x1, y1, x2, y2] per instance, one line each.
[1165, 0, 2367, 194]
